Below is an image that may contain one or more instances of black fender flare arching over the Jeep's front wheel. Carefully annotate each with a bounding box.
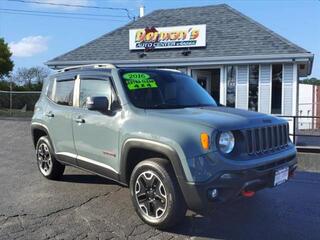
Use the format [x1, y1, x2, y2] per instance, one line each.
[120, 138, 186, 184]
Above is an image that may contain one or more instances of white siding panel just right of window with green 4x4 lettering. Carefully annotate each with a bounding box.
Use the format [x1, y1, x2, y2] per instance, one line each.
[236, 65, 249, 109]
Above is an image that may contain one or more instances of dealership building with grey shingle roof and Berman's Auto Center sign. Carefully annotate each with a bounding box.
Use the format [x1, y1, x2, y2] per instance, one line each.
[46, 4, 313, 115]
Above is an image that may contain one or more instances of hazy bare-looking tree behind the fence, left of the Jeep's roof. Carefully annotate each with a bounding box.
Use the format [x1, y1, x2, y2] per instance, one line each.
[12, 66, 50, 88]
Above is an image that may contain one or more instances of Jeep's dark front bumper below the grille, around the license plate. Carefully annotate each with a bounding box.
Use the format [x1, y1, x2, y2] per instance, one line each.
[179, 149, 297, 211]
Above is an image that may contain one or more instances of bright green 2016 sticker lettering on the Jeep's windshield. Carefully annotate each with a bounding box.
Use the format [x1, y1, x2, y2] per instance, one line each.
[123, 72, 158, 91]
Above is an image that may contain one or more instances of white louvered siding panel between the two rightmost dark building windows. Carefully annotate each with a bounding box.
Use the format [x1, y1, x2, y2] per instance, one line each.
[258, 64, 271, 113]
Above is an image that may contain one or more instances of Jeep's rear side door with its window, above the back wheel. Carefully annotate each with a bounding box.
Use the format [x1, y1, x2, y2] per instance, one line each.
[45, 74, 77, 164]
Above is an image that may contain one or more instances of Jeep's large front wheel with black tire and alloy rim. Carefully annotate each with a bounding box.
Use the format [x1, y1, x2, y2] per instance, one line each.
[130, 158, 187, 229]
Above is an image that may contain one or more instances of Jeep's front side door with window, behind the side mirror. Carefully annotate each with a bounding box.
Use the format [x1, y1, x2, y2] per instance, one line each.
[73, 75, 121, 178]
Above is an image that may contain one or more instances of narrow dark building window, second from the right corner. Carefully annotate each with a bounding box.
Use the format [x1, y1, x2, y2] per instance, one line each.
[248, 65, 259, 111]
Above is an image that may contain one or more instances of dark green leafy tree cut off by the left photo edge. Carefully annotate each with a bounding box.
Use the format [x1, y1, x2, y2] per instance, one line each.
[0, 38, 14, 79]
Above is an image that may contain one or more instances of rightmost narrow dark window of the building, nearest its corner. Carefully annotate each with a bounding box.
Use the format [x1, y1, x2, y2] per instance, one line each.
[271, 64, 282, 114]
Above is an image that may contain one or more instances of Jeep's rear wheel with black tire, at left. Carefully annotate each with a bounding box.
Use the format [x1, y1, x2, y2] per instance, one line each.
[36, 136, 65, 180]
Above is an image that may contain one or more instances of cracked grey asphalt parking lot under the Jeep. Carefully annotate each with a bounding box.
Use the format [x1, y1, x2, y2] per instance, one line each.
[0, 120, 320, 240]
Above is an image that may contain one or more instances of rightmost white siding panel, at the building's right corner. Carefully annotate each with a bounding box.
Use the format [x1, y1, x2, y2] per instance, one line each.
[282, 64, 293, 115]
